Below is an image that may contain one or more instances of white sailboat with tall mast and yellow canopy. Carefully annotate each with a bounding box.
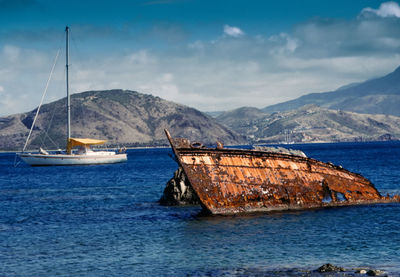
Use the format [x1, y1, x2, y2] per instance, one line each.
[18, 26, 127, 166]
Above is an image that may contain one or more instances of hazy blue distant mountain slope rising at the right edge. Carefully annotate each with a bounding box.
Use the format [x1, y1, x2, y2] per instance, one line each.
[262, 67, 400, 116]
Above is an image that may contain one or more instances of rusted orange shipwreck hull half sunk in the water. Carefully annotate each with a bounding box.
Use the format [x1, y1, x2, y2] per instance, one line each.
[165, 130, 400, 214]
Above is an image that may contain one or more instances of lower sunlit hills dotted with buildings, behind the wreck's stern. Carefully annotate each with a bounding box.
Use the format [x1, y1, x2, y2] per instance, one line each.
[217, 105, 400, 143]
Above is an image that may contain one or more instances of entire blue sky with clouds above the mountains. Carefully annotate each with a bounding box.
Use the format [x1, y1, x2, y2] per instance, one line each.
[0, 0, 400, 116]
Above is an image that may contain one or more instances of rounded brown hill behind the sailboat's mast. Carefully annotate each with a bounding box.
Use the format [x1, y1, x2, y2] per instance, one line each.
[0, 90, 245, 150]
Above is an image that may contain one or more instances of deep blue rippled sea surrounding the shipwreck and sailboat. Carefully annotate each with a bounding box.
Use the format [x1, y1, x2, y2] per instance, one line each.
[0, 142, 400, 277]
